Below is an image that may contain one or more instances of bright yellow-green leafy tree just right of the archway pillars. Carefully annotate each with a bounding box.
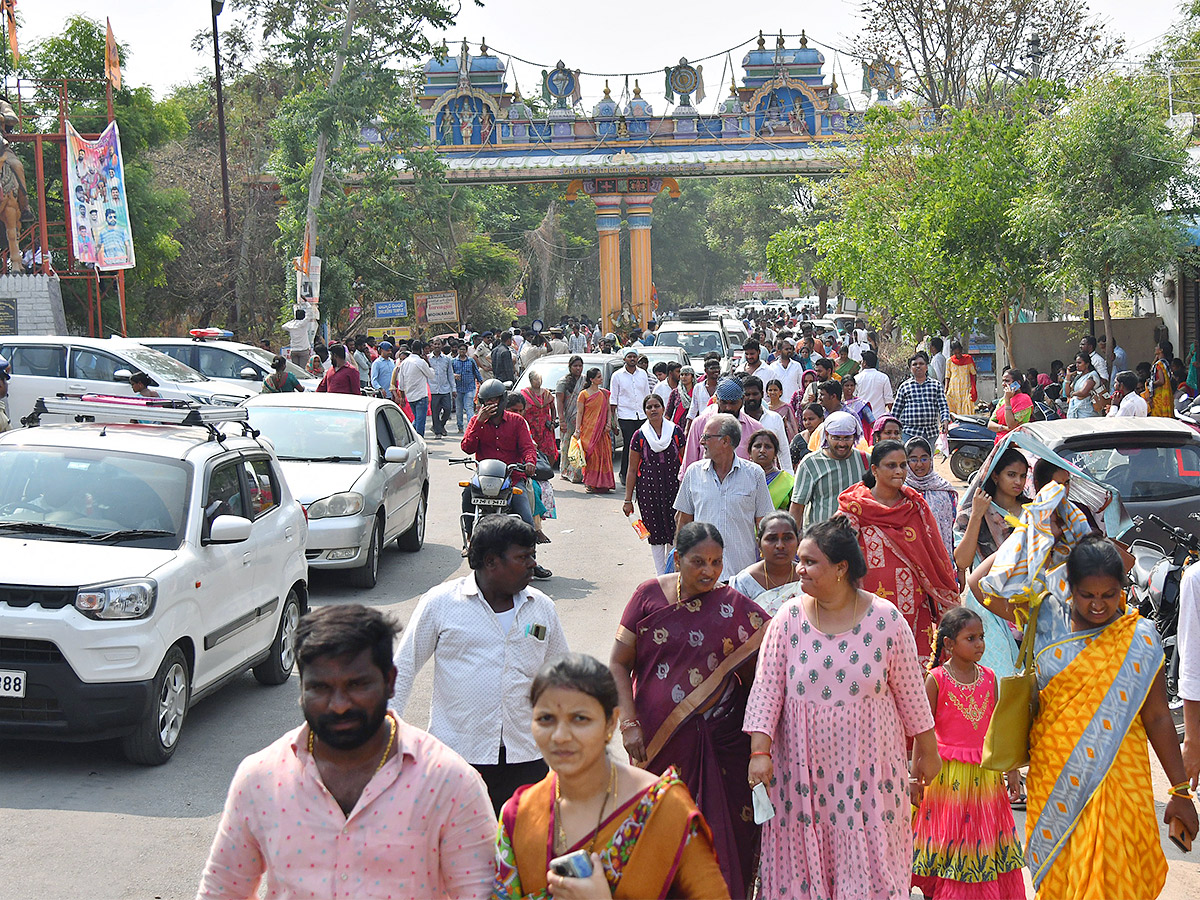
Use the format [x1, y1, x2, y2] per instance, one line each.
[814, 99, 1037, 348]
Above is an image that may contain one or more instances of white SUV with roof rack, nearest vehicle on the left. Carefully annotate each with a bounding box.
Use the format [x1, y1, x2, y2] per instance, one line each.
[0, 397, 308, 764]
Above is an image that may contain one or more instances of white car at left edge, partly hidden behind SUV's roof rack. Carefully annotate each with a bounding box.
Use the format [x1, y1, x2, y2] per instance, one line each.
[0, 335, 258, 425]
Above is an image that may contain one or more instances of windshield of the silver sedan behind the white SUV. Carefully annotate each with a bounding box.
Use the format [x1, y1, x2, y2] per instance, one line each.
[246, 406, 367, 462]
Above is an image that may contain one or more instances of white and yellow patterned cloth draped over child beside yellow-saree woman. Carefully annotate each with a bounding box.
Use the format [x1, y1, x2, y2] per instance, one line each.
[979, 481, 1092, 619]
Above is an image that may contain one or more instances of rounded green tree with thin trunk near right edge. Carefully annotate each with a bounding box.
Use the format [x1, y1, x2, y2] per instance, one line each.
[1010, 76, 1196, 372]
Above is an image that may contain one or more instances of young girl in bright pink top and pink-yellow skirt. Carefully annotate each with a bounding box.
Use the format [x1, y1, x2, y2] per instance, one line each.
[912, 606, 1025, 900]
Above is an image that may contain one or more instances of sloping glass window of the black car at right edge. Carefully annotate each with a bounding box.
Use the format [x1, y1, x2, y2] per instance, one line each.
[1058, 443, 1200, 503]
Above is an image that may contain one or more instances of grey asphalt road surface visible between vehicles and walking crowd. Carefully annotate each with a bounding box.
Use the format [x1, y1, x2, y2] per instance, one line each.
[0, 437, 1200, 900]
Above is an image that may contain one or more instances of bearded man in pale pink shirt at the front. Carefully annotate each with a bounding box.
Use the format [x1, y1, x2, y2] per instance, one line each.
[197, 605, 496, 900]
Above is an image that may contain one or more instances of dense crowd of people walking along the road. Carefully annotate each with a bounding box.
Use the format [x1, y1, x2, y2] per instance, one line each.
[199, 309, 1200, 900]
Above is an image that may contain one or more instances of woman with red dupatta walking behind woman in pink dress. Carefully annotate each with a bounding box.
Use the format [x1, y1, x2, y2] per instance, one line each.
[838, 440, 959, 659]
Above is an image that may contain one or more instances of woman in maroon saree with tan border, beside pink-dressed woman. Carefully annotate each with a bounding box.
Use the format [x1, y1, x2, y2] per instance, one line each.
[610, 522, 769, 898]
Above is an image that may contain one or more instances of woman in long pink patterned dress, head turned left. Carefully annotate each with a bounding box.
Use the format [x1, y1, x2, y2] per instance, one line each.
[743, 515, 941, 900]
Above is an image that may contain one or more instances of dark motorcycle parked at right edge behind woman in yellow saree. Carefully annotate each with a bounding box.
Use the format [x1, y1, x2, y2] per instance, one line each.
[1129, 512, 1200, 724]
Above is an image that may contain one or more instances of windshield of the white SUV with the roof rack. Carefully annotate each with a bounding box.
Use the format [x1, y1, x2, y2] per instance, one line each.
[0, 446, 191, 548]
